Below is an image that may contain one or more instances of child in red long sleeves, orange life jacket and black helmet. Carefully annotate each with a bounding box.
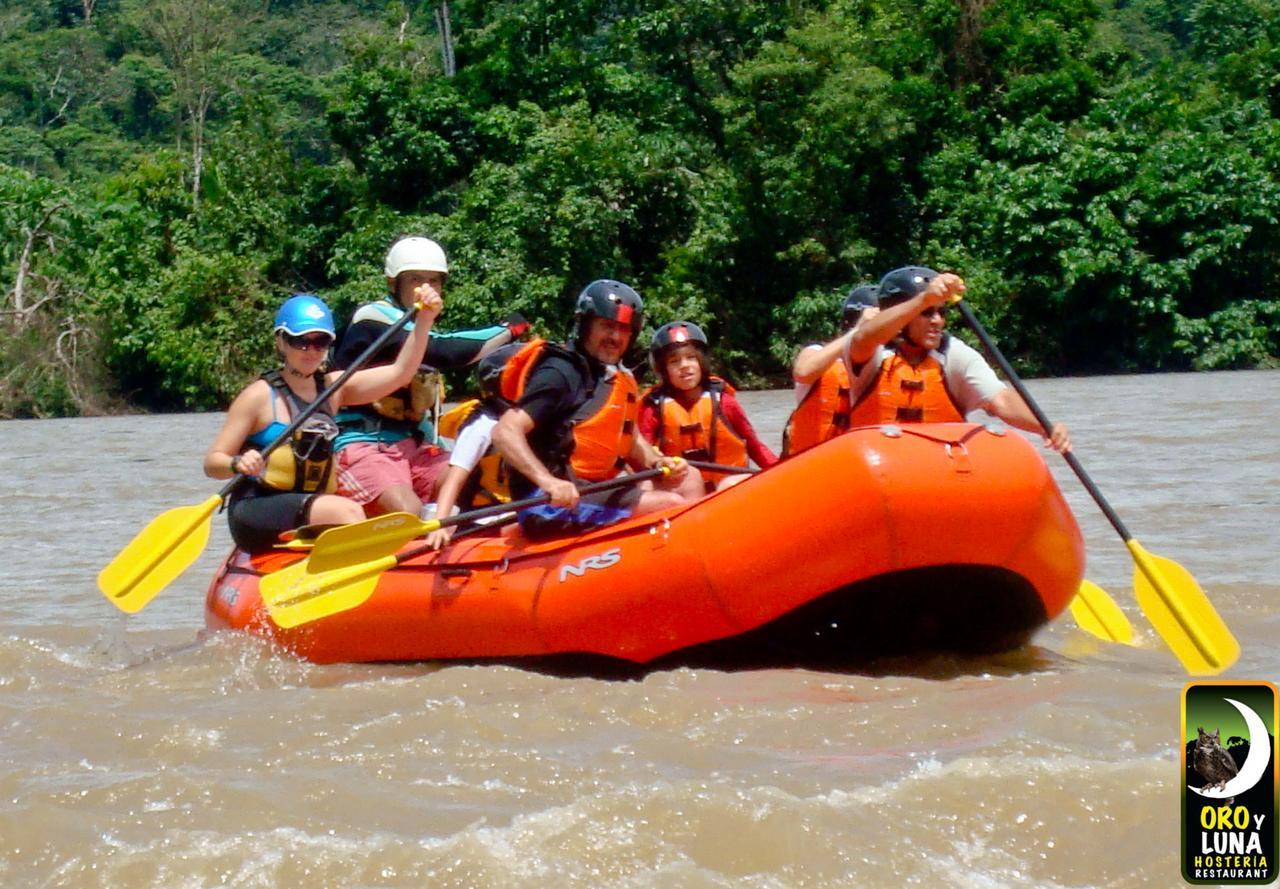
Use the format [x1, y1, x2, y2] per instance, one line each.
[640, 321, 778, 491]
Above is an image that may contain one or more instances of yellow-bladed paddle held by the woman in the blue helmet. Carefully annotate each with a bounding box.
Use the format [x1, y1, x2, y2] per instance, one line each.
[97, 299, 417, 614]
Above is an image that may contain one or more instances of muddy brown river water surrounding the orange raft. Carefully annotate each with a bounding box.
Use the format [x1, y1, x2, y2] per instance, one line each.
[0, 371, 1280, 889]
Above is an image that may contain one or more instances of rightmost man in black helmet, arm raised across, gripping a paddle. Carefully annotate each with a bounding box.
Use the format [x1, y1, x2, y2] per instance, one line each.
[849, 266, 1071, 452]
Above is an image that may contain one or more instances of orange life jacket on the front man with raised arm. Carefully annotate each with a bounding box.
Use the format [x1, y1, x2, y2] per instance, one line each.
[851, 338, 964, 426]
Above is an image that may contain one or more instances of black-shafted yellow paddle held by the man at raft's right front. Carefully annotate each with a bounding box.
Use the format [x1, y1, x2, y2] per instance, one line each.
[955, 301, 1240, 675]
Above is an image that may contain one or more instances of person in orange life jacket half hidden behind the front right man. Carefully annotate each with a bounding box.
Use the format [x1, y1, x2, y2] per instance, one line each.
[782, 284, 879, 457]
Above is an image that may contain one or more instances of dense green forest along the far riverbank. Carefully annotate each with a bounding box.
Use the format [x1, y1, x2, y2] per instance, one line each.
[0, 0, 1280, 417]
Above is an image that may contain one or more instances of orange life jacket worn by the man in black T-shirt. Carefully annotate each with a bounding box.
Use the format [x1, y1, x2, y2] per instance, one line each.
[494, 339, 640, 481]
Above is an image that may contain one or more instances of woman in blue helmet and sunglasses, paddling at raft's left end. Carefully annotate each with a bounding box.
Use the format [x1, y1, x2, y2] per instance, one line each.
[205, 288, 444, 553]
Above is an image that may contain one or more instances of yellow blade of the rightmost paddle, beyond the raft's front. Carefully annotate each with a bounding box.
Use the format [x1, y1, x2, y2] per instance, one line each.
[1125, 540, 1240, 675]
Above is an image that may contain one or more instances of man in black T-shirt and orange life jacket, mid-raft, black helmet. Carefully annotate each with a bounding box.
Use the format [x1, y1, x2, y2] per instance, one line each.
[493, 280, 703, 530]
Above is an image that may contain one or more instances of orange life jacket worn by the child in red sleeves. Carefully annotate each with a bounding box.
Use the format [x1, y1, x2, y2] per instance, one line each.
[644, 376, 748, 487]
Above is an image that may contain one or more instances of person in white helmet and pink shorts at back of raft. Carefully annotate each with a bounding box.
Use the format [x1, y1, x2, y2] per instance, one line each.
[334, 237, 529, 514]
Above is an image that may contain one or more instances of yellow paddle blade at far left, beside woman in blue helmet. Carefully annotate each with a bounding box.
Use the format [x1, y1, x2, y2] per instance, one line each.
[97, 494, 223, 614]
